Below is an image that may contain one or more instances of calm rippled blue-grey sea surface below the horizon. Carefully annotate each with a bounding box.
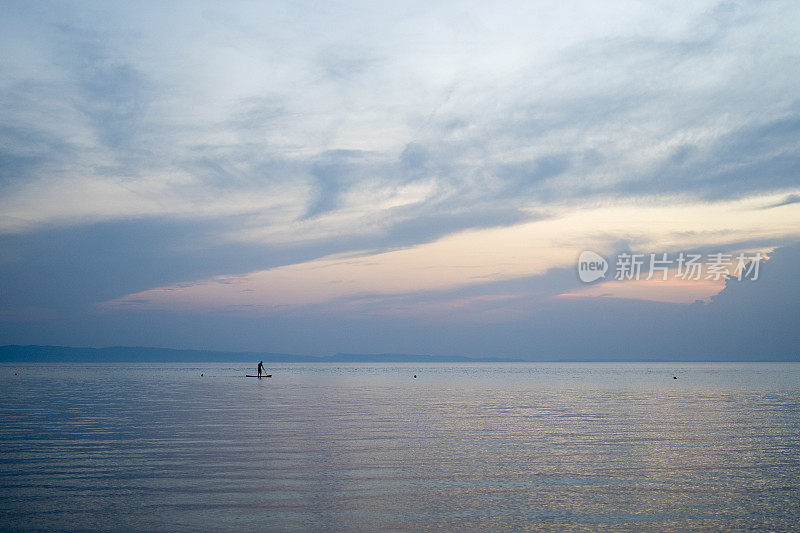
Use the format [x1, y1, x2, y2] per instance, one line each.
[0, 364, 800, 531]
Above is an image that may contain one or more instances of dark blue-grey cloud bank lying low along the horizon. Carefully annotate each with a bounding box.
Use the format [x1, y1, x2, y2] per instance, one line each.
[4, 245, 800, 361]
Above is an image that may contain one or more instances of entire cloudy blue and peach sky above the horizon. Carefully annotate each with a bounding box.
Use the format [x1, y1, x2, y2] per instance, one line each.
[0, 0, 800, 360]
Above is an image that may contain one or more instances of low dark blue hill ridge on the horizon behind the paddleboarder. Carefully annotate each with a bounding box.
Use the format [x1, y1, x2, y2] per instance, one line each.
[0, 345, 521, 363]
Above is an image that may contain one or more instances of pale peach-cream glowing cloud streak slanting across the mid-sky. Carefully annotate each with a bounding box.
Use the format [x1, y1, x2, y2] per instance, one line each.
[107, 193, 800, 309]
